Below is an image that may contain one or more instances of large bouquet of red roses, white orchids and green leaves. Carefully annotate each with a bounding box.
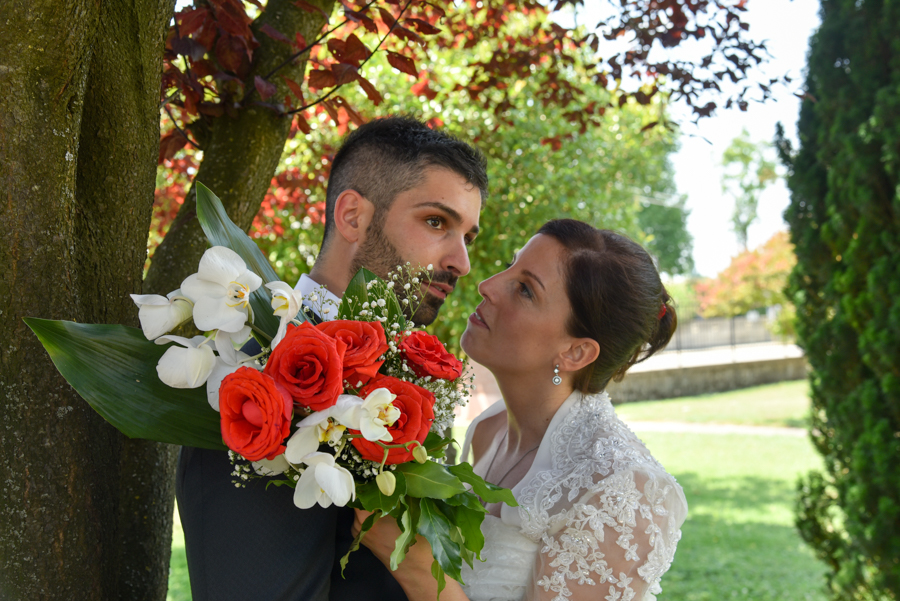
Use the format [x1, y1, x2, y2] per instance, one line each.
[26, 183, 515, 590]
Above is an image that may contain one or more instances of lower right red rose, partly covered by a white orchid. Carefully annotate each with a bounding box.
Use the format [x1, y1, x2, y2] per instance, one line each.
[352, 376, 434, 465]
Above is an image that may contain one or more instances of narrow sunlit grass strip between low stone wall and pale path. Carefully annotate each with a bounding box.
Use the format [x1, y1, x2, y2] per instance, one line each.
[616, 380, 809, 428]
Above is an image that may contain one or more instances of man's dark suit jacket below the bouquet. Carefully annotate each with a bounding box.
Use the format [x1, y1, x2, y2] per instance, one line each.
[175, 328, 406, 601]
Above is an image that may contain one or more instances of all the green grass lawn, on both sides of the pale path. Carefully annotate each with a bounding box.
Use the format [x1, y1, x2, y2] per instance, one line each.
[168, 382, 826, 601]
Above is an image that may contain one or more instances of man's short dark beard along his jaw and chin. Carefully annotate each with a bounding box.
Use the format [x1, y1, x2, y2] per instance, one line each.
[350, 220, 459, 326]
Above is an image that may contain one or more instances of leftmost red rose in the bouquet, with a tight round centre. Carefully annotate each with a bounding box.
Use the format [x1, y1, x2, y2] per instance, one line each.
[219, 367, 294, 461]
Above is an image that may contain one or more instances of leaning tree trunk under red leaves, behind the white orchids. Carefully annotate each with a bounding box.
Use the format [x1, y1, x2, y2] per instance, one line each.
[144, 0, 334, 294]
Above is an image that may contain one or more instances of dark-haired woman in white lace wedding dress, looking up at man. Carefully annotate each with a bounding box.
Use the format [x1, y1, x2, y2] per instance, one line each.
[355, 219, 687, 601]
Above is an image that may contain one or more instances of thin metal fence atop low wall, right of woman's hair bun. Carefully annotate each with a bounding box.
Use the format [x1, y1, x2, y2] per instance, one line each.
[662, 315, 777, 352]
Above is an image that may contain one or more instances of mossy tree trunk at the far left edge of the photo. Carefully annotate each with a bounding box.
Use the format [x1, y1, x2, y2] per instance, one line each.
[0, 0, 107, 600]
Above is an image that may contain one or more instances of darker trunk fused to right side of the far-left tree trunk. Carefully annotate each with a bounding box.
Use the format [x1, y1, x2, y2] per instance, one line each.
[74, 0, 177, 600]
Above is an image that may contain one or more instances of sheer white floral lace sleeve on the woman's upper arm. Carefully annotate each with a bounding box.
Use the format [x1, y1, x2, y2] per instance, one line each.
[527, 470, 686, 601]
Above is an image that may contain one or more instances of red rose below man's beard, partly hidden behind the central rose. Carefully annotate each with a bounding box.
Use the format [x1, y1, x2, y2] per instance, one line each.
[316, 319, 388, 388]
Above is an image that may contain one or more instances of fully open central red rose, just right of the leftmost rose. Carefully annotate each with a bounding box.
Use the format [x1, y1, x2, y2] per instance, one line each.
[263, 322, 347, 411]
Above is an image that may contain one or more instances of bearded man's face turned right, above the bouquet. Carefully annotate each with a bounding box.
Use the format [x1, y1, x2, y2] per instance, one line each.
[351, 167, 481, 325]
